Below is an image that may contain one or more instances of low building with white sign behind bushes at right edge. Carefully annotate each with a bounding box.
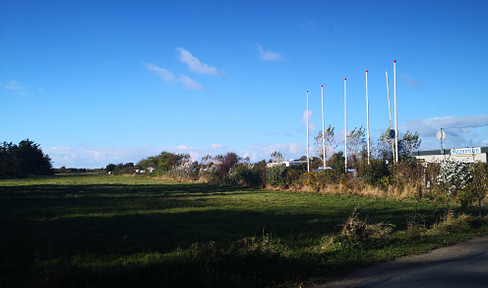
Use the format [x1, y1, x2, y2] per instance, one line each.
[412, 147, 488, 163]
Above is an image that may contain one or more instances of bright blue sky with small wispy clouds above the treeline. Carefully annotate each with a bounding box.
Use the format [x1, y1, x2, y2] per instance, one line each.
[0, 0, 488, 168]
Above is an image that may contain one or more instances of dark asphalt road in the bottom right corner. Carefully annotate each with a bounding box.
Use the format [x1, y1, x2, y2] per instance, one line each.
[314, 237, 488, 288]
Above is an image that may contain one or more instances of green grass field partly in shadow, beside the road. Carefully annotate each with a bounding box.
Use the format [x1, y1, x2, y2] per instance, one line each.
[0, 175, 488, 287]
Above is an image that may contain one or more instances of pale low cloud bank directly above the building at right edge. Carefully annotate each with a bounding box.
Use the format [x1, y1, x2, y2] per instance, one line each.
[400, 115, 488, 149]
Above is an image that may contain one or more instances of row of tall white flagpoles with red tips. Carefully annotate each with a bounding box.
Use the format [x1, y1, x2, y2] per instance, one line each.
[306, 60, 398, 173]
